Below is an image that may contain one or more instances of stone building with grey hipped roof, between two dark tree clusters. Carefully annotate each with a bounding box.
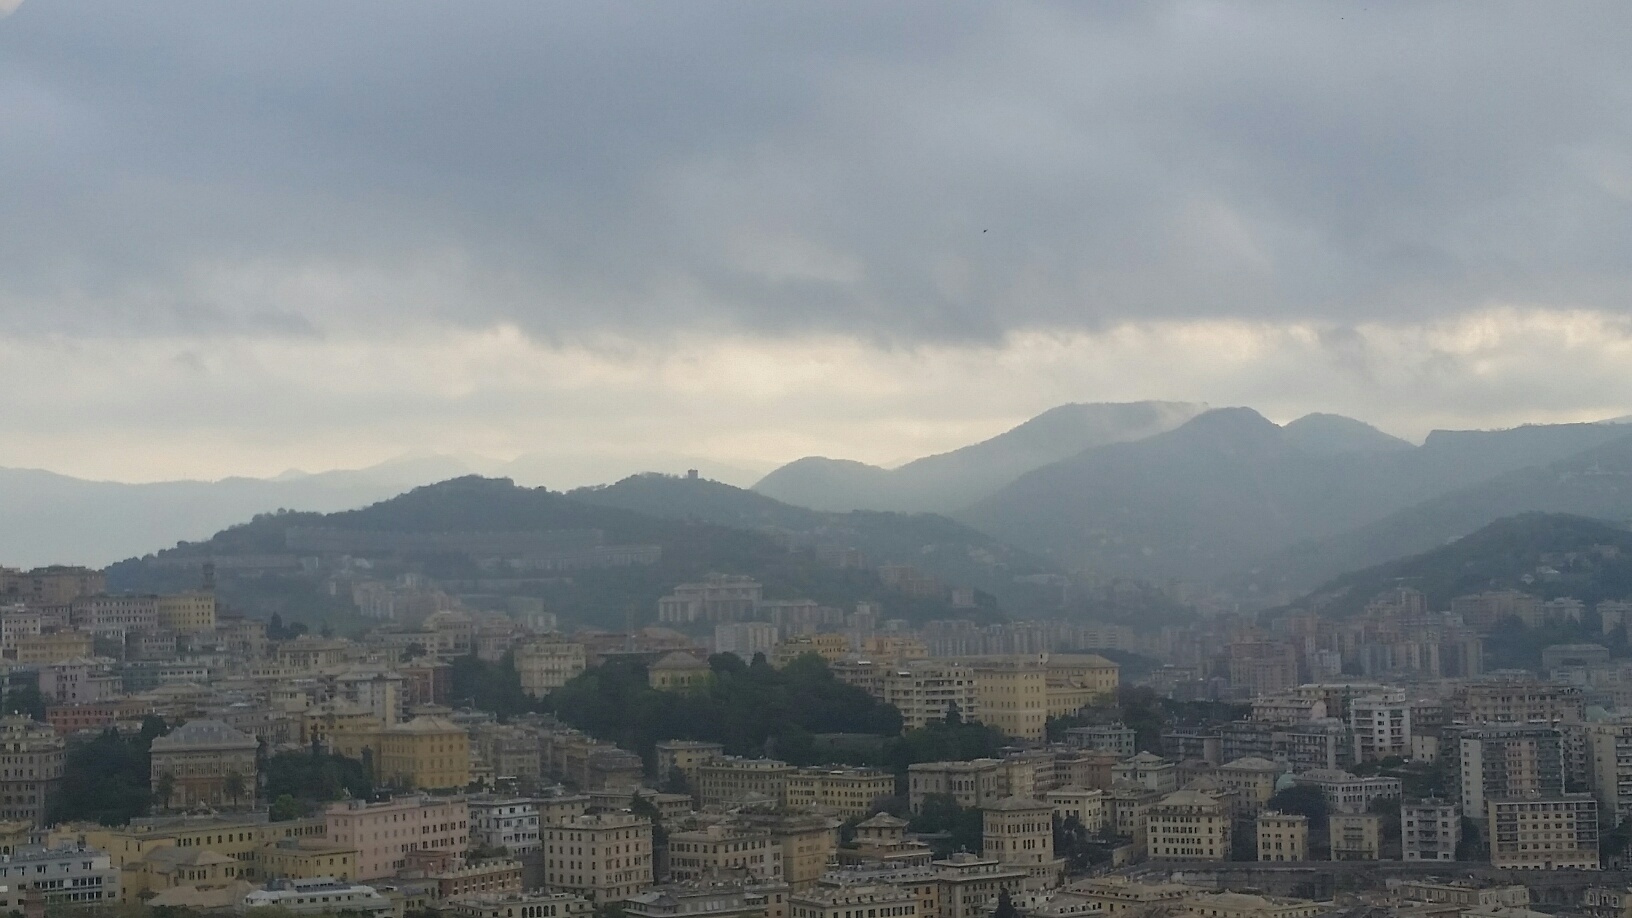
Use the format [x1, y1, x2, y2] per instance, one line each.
[150, 720, 259, 810]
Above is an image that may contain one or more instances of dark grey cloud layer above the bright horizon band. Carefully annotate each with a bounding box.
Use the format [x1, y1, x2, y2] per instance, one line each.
[0, 0, 1632, 341]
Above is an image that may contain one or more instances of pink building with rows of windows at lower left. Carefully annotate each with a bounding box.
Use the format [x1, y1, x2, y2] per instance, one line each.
[323, 794, 470, 880]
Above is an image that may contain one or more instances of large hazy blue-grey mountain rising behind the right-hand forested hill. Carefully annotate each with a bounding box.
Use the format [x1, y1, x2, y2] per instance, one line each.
[955, 408, 1625, 582]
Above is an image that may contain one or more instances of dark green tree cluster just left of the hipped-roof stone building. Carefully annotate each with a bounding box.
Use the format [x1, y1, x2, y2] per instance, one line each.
[46, 717, 166, 825]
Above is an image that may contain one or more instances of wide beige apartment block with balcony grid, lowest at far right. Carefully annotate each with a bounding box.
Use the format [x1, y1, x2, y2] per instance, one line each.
[1485, 794, 1598, 871]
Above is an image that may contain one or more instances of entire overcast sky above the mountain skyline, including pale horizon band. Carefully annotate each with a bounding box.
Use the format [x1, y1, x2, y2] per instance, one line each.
[0, 0, 1632, 487]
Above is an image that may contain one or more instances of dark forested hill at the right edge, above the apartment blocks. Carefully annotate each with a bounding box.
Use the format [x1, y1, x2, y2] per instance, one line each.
[1294, 513, 1632, 616]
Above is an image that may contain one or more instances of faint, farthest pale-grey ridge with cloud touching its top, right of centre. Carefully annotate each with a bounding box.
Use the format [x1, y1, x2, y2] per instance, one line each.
[754, 402, 1206, 513]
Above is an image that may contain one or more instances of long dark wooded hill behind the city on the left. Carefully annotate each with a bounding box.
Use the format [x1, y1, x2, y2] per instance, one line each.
[109, 477, 1024, 627]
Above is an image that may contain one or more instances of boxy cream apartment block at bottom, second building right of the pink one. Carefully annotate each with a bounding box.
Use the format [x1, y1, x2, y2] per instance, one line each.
[540, 812, 653, 905]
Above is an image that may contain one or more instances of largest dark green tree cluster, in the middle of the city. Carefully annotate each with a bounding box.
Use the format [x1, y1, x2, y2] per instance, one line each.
[547, 653, 901, 764]
